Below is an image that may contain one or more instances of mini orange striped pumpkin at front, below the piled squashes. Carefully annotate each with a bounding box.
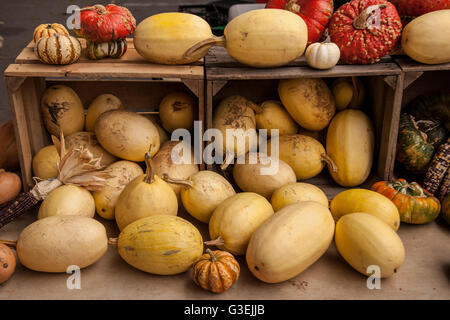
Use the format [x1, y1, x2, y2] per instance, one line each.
[192, 249, 240, 293]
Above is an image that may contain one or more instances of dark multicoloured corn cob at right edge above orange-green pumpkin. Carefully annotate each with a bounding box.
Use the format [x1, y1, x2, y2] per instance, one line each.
[423, 139, 450, 194]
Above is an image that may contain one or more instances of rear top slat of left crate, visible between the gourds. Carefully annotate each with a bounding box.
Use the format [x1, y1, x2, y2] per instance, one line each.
[15, 38, 203, 66]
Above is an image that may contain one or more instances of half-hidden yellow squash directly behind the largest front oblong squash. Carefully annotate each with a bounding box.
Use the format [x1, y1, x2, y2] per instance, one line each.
[270, 182, 328, 212]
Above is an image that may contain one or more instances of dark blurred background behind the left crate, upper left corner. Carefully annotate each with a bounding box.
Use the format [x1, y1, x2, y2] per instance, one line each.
[0, 0, 229, 123]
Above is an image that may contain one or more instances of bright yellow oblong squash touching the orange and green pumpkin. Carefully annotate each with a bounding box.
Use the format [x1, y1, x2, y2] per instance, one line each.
[330, 189, 400, 230]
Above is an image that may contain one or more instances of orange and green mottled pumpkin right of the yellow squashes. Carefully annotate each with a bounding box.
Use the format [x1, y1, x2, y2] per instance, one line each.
[372, 179, 441, 224]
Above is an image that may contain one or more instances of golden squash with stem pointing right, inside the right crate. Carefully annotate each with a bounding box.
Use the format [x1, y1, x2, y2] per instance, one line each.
[267, 134, 329, 180]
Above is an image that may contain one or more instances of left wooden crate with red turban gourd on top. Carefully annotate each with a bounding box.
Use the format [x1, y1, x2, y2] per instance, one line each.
[5, 39, 204, 190]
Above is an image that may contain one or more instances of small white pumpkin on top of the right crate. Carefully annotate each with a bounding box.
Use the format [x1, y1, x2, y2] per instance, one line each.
[305, 42, 341, 69]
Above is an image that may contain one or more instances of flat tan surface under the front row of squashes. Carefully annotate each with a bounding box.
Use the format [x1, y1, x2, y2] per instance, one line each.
[0, 205, 450, 300]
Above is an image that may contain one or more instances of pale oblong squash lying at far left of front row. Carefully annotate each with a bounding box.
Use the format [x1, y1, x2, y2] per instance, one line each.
[16, 216, 108, 272]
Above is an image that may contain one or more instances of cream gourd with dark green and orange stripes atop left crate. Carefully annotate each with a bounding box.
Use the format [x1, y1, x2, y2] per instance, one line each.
[34, 34, 81, 64]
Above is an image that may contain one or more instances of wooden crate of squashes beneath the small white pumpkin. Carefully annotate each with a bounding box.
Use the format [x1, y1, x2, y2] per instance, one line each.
[205, 48, 404, 198]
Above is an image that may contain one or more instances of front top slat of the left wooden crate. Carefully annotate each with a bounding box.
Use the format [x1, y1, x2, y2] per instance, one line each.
[5, 63, 203, 79]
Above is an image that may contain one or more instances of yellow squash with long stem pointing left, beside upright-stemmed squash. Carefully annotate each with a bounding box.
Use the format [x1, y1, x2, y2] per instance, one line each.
[164, 170, 236, 223]
